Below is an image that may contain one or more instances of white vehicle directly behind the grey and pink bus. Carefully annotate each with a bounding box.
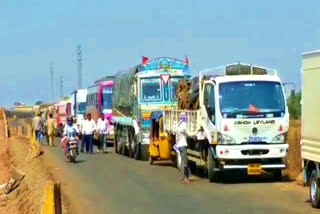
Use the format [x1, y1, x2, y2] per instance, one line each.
[70, 89, 87, 125]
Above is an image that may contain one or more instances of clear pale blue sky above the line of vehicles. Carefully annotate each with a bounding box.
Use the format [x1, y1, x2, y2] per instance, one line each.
[0, 0, 320, 107]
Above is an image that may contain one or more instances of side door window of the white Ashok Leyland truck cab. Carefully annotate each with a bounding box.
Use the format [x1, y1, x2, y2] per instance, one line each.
[204, 84, 216, 124]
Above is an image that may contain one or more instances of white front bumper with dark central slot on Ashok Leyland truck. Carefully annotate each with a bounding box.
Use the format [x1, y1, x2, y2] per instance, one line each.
[216, 144, 288, 160]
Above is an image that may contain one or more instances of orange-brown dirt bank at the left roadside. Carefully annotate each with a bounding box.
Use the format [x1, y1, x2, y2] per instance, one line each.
[0, 137, 66, 214]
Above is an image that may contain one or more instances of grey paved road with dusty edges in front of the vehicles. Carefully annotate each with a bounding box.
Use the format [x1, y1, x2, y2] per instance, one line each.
[44, 139, 319, 214]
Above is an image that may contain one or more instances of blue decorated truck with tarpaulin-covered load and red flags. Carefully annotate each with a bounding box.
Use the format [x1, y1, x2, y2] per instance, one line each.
[112, 57, 191, 160]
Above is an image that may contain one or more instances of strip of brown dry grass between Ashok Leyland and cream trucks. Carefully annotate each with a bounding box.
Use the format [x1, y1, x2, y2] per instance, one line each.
[285, 120, 302, 180]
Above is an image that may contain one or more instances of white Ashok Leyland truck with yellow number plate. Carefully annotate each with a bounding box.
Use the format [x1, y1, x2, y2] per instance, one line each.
[164, 63, 289, 182]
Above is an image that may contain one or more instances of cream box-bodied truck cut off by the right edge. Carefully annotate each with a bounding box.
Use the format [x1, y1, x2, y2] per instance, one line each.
[300, 50, 320, 208]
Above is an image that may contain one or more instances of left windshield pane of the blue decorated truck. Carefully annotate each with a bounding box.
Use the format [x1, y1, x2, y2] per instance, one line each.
[141, 78, 162, 102]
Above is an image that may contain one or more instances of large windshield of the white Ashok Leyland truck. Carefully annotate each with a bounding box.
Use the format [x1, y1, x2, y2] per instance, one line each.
[219, 81, 285, 118]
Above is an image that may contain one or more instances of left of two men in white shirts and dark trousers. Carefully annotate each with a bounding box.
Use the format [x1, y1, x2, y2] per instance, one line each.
[82, 113, 96, 154]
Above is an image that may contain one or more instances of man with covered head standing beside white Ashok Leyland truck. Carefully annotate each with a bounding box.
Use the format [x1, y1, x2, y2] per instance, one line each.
[176, 112, 196, 183]
